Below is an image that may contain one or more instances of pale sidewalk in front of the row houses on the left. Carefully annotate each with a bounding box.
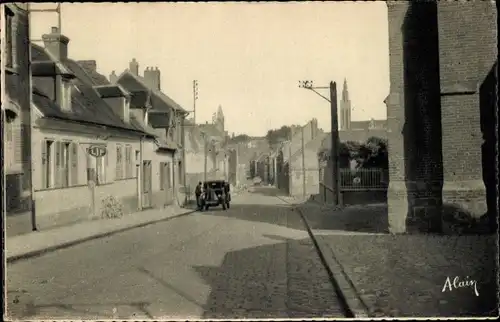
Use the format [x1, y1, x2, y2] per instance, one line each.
[5, 206, 195, 262]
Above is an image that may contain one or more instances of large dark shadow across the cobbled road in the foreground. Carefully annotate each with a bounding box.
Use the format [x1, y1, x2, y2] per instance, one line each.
[194, 236, 345, 319]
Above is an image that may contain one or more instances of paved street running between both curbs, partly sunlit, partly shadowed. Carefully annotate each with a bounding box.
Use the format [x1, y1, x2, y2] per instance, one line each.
[7, 188, 344, 319]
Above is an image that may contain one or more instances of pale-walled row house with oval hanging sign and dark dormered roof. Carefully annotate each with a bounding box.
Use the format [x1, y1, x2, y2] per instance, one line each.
[8, 27, 182, 233]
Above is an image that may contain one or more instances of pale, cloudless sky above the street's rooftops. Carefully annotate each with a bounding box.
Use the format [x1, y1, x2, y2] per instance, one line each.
[31, 1, 389, 136]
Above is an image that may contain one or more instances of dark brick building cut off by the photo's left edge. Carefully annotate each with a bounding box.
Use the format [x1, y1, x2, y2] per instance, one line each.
[0, 3, 32, 217]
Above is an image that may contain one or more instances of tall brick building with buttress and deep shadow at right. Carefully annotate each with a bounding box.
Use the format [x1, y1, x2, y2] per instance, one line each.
[385, 1, 497, 233]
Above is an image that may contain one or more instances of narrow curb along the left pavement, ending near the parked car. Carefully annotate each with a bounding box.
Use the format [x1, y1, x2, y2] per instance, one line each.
[6, 209, 196, 264]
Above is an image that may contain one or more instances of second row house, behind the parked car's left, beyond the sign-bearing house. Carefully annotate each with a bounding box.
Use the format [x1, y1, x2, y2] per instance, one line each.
[110, 58, 188, 203]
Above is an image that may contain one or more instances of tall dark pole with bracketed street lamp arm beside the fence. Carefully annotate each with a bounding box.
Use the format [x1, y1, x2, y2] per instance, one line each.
[299, 80, 340, 206]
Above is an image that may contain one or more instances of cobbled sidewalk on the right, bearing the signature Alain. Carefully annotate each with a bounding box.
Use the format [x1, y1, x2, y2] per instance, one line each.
[296, 202, 498, 317]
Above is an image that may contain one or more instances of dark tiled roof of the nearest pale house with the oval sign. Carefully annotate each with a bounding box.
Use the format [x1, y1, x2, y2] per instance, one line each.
[32, 45, 151, 133]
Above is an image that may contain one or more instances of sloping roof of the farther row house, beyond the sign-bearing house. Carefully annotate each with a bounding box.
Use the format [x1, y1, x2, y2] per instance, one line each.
[118, 70, 185, 112]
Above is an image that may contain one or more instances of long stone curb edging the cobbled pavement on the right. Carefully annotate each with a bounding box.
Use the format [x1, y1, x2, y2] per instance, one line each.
[278, 197, 370, 318]
